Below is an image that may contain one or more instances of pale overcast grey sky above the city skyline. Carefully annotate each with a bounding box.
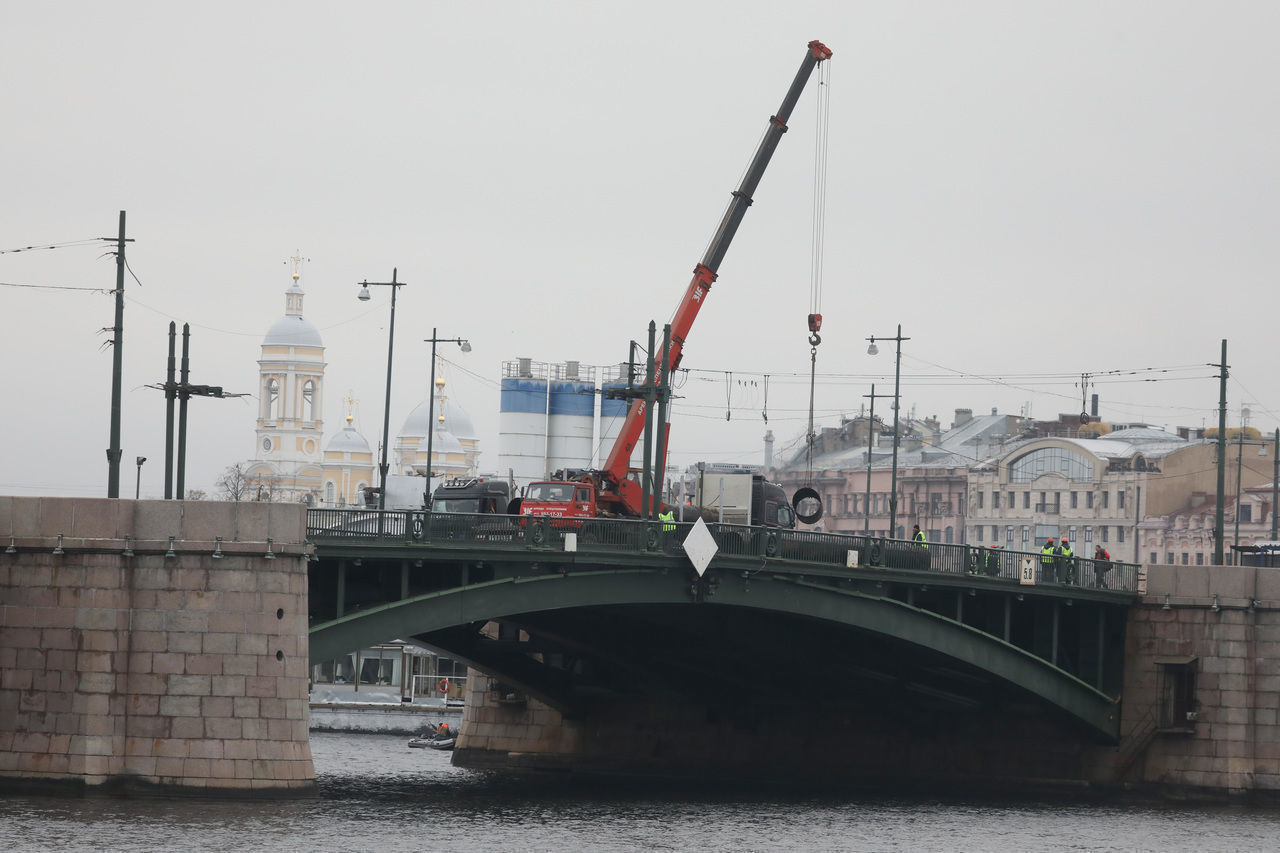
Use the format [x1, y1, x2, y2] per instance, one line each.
[0, 0, 1280, 496]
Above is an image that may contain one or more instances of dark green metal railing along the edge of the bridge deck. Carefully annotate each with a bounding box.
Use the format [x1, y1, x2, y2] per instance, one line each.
[307, 510, 1138, 593]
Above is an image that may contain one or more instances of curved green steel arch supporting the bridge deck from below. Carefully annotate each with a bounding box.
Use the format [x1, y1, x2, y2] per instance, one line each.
[310, 566, 1120, 743]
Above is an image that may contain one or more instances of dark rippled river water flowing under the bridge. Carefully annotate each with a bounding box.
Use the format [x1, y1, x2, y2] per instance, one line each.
[0, 733, 1280, 853]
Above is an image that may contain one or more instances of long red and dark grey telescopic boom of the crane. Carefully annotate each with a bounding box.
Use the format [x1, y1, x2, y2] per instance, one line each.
[599, 41, 831, 516]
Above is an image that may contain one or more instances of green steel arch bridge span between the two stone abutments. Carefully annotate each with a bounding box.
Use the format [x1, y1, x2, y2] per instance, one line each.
[307, 510, 1138, 743]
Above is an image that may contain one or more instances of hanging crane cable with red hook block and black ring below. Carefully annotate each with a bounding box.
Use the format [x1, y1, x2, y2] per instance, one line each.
[791, 61, 831, 524]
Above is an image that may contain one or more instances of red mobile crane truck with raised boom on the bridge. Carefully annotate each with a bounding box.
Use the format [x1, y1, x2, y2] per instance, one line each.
[521, 41, 831, 517]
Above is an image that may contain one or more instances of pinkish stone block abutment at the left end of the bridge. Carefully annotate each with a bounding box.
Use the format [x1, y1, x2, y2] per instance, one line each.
[0, 497, 315, 793]
